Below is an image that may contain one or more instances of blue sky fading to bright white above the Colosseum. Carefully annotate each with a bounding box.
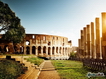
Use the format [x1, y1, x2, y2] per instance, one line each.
[1, 0, 106, 46]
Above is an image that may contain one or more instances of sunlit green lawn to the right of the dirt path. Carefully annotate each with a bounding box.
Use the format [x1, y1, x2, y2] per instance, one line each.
[52, 60, 106, 79]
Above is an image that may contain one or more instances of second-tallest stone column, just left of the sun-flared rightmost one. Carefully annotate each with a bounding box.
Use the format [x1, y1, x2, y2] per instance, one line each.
[95, 18, 102, 59]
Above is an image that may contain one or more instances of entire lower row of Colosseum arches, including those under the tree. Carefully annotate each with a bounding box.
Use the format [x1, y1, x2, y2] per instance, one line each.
[0, 45, 69, 55]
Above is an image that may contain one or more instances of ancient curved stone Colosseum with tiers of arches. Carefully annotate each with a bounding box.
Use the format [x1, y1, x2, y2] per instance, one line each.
[0, 34, 72, 59]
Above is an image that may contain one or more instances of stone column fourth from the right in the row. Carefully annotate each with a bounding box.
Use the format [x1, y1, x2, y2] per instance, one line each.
[87, 25, 91, 58]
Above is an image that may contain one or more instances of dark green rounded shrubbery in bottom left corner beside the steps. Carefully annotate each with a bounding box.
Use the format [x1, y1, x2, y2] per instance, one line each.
[0, 59, 23, 79]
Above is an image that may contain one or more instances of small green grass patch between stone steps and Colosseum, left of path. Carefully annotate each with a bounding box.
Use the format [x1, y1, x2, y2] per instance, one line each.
[25, 56, 43, 66]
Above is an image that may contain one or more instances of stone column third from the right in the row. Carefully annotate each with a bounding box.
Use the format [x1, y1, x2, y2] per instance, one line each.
[91, 22, 96, 59]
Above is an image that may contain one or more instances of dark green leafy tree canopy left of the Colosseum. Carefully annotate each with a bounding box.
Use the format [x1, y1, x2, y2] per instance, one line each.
[0, 1, 25, 43]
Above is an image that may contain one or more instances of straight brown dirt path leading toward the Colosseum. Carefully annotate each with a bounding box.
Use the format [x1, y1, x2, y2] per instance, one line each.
[38, 60, 60, 79]
